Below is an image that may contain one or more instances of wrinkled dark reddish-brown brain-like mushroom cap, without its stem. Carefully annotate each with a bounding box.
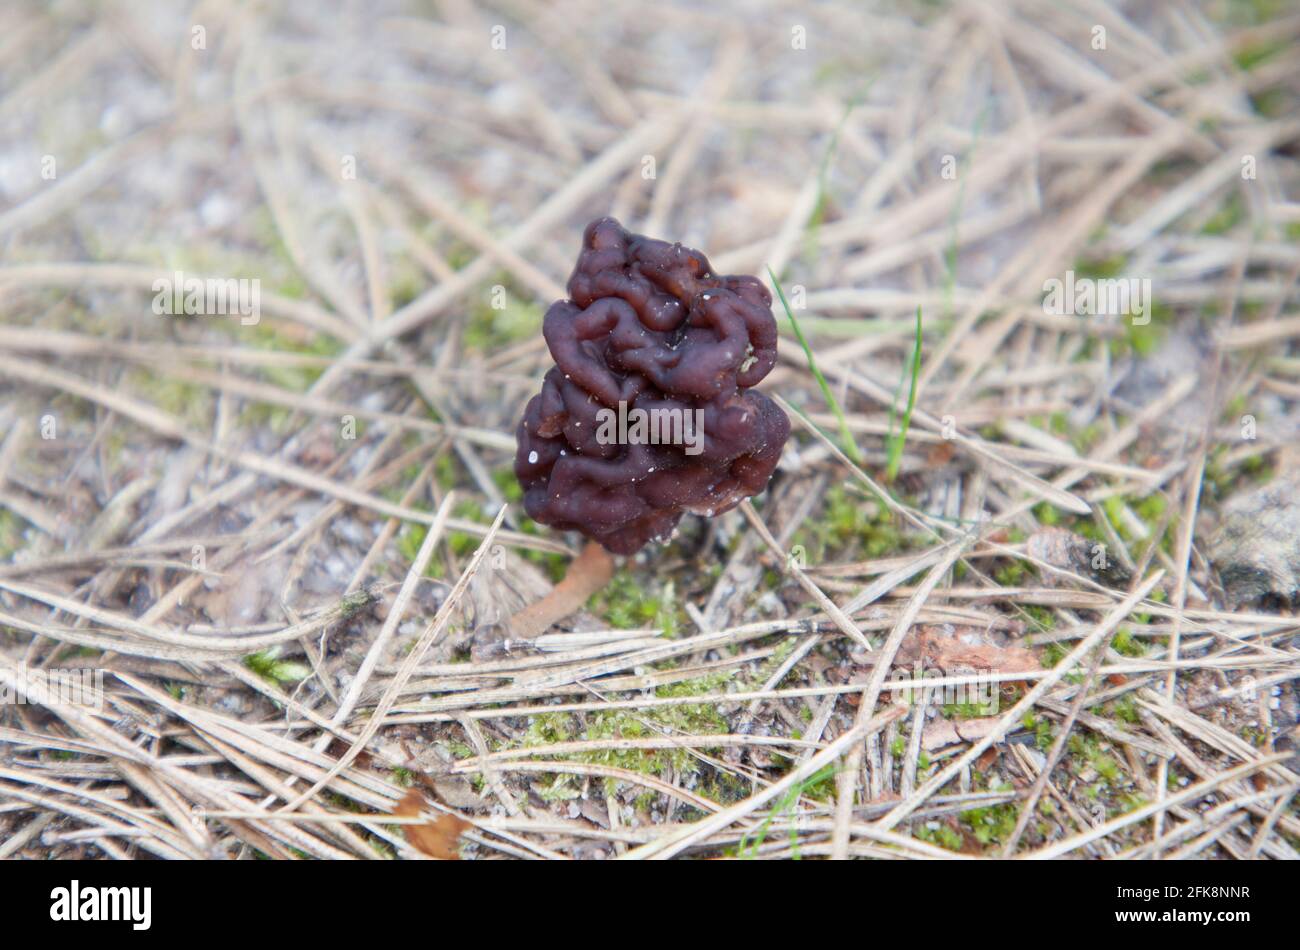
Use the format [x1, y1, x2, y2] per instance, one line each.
[515, 218, 790, 554]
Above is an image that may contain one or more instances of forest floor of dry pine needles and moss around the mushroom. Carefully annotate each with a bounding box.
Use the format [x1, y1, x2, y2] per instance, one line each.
[0, 0, 1300, 859]
